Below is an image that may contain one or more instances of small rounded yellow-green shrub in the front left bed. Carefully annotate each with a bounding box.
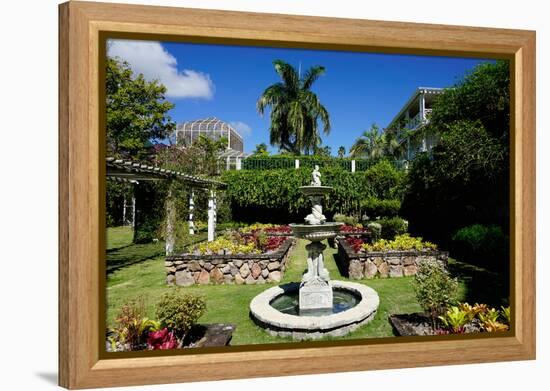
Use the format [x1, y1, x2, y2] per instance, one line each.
[156, 289, 206, 339]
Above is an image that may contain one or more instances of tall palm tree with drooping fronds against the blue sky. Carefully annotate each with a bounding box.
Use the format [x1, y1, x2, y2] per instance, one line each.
[256, 60, 330, 155]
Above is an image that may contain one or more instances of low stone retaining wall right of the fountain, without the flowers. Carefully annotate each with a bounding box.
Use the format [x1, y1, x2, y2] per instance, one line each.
[338, 240, 449, 280]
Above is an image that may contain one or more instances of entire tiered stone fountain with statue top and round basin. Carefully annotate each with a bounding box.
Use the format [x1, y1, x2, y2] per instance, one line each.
[250, 166, 379, 340]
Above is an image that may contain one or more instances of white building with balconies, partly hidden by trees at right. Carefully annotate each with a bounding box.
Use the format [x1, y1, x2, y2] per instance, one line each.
[387, 87, 443, 161]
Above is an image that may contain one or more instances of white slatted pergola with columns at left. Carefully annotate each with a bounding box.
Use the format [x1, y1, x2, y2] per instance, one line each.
[106, 157, 227, 255]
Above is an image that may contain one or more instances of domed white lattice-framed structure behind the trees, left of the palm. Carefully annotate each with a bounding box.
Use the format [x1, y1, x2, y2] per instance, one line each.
[176, 117, 244, 153]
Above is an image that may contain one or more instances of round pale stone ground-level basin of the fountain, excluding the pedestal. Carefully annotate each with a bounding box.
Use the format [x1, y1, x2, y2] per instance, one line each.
[250, 280, 380, 341]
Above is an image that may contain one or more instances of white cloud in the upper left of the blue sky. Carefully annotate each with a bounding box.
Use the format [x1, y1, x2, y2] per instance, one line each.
[107, 40, 214, 99]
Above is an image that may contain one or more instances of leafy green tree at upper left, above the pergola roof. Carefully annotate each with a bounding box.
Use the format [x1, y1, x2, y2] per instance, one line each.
[106, 58, 175, 160]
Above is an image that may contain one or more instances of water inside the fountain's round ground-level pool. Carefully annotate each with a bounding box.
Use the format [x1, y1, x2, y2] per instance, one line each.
[269, 289, 360, 316]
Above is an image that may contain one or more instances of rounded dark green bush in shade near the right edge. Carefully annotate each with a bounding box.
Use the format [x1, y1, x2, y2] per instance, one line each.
[450, 224, 508, 270]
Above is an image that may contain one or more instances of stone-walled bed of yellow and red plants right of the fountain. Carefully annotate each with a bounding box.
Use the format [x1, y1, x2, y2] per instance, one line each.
[338, 235, 449, 279]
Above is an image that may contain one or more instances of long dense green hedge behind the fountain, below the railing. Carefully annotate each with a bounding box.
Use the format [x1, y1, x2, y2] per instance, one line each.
[221, 161, 404, 223]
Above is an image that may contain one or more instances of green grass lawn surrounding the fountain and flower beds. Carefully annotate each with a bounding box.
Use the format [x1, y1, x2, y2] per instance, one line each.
[107, 228, 512, 345]
